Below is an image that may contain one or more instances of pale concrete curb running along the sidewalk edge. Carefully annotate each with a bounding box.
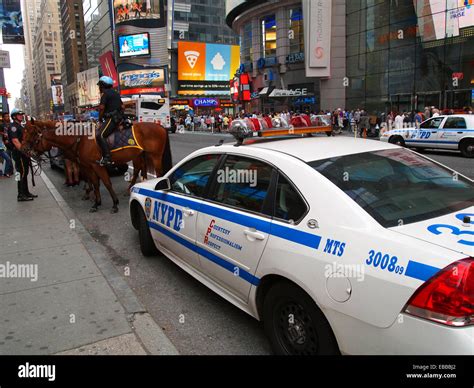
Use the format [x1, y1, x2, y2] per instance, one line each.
[41, 171, 179, 355]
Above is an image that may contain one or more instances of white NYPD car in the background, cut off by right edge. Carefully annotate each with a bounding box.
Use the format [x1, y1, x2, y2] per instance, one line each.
[380, 115, 474, 158]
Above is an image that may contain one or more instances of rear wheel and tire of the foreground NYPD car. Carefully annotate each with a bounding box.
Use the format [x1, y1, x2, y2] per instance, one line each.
[263, 282, 340, 355]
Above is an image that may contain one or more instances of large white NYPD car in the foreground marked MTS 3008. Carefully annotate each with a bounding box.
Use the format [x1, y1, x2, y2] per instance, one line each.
[130, 130, 474, 355]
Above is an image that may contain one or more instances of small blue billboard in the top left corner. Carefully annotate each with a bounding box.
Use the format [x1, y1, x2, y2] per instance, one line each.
[0, 0, 25, 44]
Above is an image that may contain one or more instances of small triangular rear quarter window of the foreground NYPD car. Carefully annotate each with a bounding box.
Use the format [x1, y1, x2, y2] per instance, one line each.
[275, 174, 308, 222]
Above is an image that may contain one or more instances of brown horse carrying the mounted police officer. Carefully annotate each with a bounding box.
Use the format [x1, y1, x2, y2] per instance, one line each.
[24, 121, 172, 213]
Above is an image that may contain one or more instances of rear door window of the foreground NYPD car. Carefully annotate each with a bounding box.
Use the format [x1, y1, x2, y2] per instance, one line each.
[213, 155, 273, 213]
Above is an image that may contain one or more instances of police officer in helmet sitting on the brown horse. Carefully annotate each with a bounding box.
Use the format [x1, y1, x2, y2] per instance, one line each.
[96, 76, 123, 166]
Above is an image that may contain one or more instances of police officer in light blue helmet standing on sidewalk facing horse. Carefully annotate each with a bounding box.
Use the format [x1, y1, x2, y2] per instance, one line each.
[8, 108, 38, 202]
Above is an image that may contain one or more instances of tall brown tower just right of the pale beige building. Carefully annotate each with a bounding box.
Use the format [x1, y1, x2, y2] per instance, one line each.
[60, 0, 87, 114]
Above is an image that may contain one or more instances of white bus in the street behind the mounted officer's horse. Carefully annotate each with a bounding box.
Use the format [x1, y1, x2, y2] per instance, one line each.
[124, 96, 171, 129]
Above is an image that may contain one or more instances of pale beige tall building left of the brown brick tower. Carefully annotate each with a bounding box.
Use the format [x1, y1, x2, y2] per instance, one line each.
[32, 0, 63, 117]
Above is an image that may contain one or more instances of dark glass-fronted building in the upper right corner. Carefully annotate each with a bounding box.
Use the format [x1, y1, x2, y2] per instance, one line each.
[346, 0, 474, 112]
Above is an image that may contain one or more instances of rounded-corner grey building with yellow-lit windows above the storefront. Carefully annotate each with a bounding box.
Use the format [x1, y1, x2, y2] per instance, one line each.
[226, 0, 346, 113]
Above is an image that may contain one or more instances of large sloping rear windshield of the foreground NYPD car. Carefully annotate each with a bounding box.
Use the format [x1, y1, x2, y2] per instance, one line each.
[308, 149, 474, 227]
